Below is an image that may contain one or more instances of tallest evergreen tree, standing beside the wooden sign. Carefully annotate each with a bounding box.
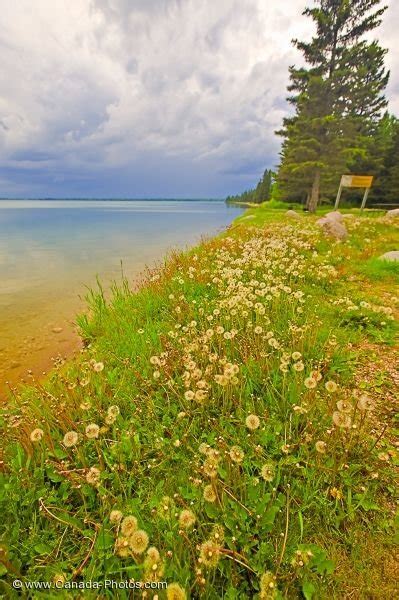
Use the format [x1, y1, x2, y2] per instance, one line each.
[278, 0, 389, 211]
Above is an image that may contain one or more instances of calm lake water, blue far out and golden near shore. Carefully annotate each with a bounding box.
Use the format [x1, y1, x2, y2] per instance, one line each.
[0, 200, 241, 389]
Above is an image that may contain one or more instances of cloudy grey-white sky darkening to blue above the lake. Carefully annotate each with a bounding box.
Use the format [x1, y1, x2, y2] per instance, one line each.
[0, 0, 399, 197]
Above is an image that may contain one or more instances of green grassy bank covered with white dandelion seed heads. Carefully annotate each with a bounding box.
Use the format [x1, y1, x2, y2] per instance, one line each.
[0, 207, 399, 600]
